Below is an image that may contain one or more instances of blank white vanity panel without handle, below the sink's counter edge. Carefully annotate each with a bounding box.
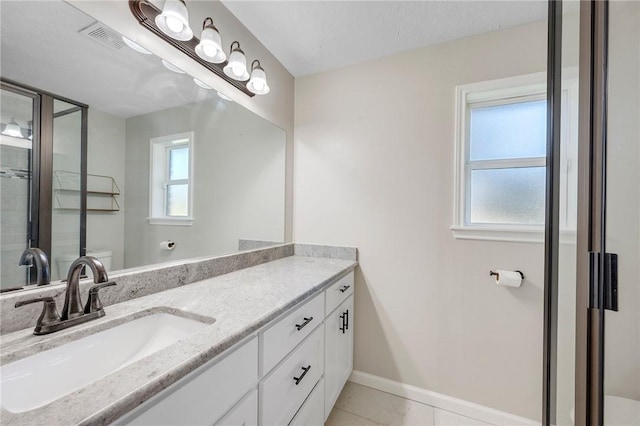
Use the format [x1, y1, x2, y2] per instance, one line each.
[116, 338, 258, 426]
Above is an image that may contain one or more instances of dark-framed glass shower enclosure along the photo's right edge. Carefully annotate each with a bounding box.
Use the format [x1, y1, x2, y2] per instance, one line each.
[543, 1, 640, 426]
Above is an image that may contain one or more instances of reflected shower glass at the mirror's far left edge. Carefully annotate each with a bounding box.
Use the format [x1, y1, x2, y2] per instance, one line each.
[0, 87, 36, 290]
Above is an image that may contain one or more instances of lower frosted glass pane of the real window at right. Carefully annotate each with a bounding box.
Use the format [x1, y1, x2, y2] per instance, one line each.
[470, 167, 546, 225]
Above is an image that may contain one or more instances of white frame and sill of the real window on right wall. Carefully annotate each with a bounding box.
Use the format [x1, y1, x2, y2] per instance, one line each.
[451, 70, 578, 243]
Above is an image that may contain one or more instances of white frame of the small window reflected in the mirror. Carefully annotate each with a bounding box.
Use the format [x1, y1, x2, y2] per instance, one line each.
[147, 132, 194, 226]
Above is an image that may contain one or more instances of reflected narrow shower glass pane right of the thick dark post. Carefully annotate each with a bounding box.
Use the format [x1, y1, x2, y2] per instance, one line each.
[51, 99, 82, 280]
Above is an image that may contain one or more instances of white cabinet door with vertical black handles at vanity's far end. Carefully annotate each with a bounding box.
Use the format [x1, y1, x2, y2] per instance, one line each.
[324, 295, 353, 421]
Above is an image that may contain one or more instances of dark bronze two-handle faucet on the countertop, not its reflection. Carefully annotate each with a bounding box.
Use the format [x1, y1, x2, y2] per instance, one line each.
[15, 256, 116, 335]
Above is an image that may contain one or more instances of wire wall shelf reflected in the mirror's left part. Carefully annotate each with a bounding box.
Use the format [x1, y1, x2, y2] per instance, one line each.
[53, 170, 120, 212]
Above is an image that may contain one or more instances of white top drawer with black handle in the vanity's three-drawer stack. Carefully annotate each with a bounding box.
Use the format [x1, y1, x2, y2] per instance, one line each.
[261, 293, 325, 374]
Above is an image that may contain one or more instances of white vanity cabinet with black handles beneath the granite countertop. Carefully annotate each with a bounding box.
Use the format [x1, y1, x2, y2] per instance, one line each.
[116, 272, 353, 426]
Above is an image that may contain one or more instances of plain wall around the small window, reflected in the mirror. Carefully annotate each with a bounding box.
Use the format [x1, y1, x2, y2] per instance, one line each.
[124, 97, 286, 268]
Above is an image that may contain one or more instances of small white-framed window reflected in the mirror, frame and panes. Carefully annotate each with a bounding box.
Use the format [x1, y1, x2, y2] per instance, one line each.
[149, 132, 193, 225]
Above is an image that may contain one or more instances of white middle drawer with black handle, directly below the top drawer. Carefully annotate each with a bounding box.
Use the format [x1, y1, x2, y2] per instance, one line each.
[260, 327, 324, 425]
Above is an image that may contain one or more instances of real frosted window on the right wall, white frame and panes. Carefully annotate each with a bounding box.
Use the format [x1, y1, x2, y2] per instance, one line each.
[452, 73, 577, 241]
